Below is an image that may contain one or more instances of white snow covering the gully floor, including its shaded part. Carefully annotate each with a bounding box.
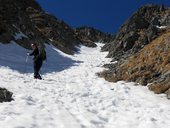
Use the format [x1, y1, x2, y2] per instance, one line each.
[0, 44, 170, 128]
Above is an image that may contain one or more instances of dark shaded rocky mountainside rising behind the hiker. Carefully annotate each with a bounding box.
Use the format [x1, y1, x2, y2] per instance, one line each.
[0, 0, 113, 54]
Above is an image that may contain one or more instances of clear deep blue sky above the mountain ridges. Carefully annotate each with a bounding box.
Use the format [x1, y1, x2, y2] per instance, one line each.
[37, 0, 170, 33]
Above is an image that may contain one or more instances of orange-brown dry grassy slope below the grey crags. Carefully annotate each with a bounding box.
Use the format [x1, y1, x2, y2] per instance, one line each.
[105, 29, 170, 93]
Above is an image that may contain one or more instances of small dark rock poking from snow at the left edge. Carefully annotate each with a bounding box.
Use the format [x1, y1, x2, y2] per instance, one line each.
[0, 88, 13, 103]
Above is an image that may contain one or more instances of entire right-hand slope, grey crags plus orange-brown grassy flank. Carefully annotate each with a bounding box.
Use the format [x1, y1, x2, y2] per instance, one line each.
[99, 5, 170, 98]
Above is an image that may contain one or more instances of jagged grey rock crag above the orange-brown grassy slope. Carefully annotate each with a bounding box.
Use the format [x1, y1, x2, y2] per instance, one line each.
[102, 5, 170, 60]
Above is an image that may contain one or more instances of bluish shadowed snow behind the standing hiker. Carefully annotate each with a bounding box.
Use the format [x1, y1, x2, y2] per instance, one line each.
[0, 43, 81, 74]
